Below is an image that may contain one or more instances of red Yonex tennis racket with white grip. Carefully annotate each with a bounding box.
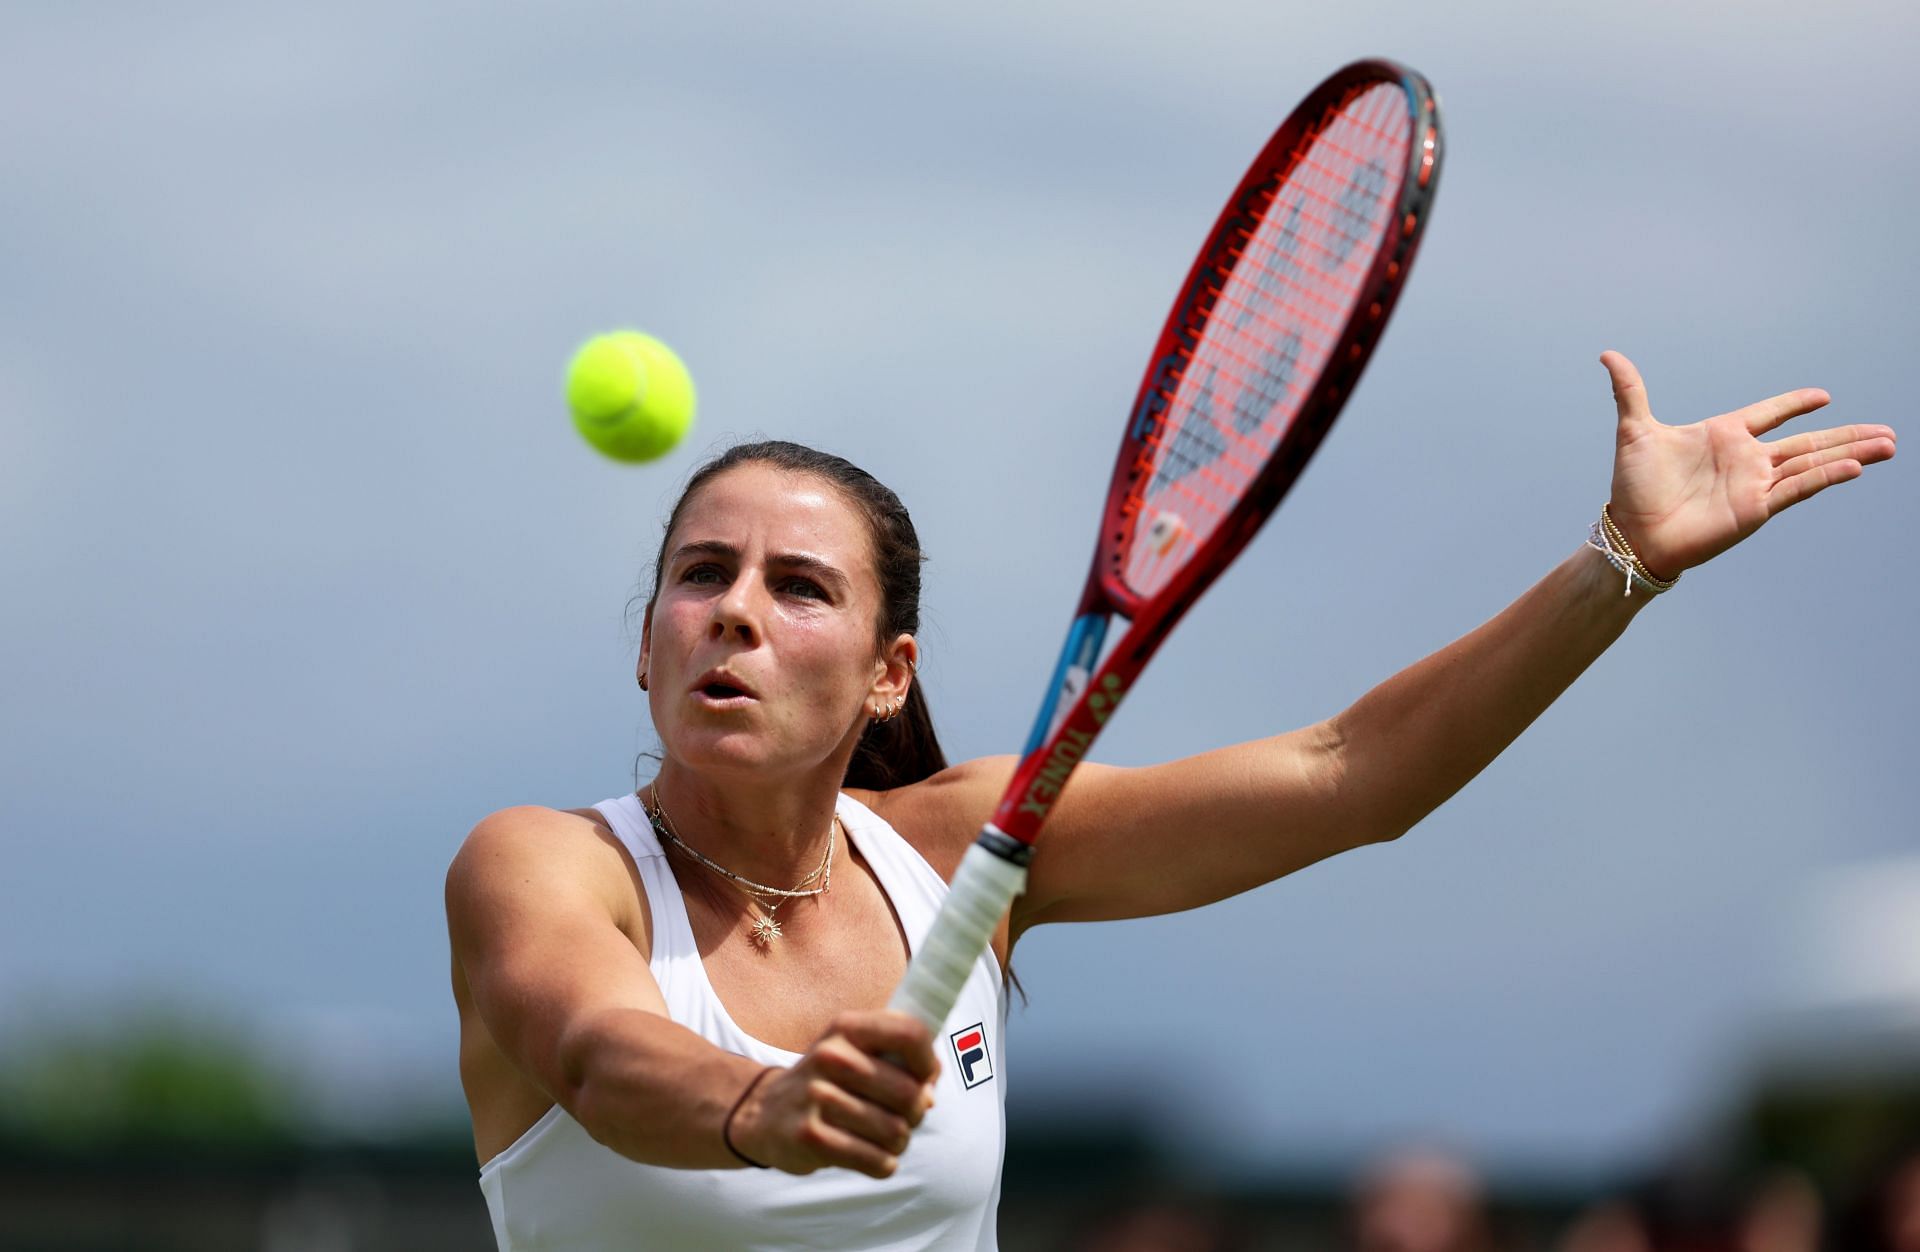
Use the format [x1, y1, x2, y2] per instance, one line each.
[891, 61, 1440, 1031]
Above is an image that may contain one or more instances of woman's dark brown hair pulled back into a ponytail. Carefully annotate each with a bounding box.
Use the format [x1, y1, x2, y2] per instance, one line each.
[647, 440, 947, 791]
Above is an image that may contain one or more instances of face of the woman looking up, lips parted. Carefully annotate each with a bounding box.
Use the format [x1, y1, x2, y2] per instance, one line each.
[641, 463, 887, 776]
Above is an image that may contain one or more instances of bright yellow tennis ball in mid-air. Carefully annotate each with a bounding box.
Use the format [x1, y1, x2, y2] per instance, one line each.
[566, 330, 693, 461]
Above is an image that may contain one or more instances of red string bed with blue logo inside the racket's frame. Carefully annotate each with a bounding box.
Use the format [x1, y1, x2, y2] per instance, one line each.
[1116, 83, 1413, 597]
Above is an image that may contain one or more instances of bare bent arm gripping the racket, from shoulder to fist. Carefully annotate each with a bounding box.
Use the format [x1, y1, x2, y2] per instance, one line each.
[447, 807, 935, 1177]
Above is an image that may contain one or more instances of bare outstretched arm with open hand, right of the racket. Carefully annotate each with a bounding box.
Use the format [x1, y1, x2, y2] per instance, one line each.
[1006, 351, 1895, 935]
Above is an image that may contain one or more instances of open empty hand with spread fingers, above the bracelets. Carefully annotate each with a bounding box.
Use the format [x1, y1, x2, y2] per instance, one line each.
[1599, 351, 1895, 578]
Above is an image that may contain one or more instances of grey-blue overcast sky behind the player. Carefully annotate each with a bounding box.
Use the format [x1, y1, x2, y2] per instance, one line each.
[0, 0, 1920, 1169]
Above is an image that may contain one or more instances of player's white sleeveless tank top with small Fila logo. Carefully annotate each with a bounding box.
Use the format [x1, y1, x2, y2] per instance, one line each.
[480, 795, 1006, 1252]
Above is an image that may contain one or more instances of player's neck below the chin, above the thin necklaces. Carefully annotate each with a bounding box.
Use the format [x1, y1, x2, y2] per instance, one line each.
[641, 758, 839, 887]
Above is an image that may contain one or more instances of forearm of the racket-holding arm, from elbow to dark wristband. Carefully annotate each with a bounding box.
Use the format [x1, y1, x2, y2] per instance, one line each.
[555, 1008, 764, 1169]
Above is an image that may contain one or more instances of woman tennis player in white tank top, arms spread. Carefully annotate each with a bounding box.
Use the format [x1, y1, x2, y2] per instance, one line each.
[447, 353, 1895, 1250]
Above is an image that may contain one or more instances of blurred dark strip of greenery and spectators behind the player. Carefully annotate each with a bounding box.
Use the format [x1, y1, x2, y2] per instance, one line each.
[0, 979, 1920, 1252]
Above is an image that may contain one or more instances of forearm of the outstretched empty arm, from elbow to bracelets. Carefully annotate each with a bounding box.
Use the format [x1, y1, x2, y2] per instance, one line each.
[1331, 547, 1649, 839]
